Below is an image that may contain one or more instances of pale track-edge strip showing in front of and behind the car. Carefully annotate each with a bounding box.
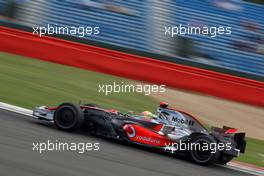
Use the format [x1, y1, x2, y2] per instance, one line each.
[0, 102, 264, 176]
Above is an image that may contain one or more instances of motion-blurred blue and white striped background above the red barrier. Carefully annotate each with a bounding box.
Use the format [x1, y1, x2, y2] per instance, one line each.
[0, 0, 264, 79]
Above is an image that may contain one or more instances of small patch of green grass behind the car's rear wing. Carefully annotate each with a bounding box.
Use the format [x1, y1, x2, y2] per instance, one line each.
[236, 138, 264, 167]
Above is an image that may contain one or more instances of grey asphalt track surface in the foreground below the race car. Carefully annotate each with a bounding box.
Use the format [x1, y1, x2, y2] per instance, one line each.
[0, 110, 253, 176]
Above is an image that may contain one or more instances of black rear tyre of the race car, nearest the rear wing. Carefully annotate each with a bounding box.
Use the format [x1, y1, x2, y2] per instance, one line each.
[189, 135, 219, 165]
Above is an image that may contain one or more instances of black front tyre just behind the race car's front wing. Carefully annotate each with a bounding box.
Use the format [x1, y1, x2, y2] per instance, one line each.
[54, 103, 84, 132]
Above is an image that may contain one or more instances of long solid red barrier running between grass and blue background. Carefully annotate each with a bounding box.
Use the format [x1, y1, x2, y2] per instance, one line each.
[0, 27, 264, 106]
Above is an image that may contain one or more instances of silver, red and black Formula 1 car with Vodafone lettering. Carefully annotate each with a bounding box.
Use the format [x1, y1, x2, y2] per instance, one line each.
[33, 102, 246, 165]
